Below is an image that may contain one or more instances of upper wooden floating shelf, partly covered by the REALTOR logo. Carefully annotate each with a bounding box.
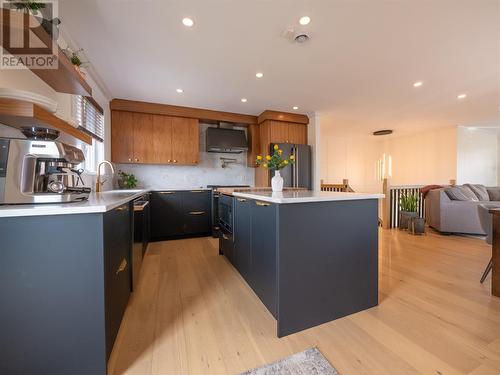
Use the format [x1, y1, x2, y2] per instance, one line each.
[0, 8, 92, 96]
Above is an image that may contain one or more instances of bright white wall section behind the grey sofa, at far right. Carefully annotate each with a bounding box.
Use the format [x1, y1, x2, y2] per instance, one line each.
[457, 127, 499, 186]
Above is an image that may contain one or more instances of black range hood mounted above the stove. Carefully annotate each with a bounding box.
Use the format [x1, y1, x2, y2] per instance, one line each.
[206, 128, 248, 154]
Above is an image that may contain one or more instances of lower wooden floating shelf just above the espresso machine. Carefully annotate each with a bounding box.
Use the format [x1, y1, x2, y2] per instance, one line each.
[0, 98, 92, 145]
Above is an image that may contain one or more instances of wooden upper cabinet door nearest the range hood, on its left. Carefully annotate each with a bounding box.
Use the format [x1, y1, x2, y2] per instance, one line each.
[172, 117, 200, 164]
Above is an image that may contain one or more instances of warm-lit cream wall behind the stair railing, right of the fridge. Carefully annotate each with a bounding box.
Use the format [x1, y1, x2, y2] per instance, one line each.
[321, 127, 457, 192]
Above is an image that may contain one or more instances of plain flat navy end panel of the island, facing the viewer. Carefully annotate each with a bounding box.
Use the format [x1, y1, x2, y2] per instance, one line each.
[277, 199, 378, 337]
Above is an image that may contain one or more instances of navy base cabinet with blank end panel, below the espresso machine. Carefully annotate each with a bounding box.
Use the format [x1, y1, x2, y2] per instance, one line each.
[0, 203, 133, 375]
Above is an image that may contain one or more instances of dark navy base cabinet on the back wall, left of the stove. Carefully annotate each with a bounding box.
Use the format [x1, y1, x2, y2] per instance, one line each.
[150, 190, 212, 241]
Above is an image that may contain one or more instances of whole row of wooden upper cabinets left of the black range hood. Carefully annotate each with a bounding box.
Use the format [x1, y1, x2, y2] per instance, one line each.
[111, 111, 200, 164]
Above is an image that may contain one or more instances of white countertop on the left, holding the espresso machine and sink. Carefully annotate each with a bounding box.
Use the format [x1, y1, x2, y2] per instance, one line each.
[0, 189, 150, 217]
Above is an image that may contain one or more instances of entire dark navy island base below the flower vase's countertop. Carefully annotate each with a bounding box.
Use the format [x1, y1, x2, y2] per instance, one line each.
[232, 194, 378, 337]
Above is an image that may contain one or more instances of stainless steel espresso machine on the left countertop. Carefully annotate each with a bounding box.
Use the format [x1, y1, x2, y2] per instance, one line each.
[0, 138, 90, 204]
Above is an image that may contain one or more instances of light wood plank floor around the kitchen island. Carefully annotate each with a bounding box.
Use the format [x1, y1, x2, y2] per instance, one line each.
[110, 230, 500, 375]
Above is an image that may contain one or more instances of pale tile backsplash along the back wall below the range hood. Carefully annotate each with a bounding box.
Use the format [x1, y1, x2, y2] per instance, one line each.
[117, 124, 255, 189]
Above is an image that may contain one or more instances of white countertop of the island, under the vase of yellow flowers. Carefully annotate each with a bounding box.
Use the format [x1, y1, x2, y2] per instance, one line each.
[233, 190, 384, 204]
